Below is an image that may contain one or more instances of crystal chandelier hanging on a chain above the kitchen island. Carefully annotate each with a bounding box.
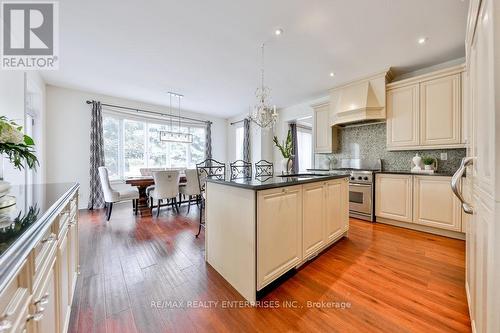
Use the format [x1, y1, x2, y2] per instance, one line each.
[249, 43, 278, 129]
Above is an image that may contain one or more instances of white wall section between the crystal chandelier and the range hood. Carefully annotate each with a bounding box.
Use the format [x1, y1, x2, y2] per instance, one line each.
[271, 96, 328, 172]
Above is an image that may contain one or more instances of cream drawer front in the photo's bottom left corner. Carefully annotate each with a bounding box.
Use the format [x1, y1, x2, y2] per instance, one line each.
[0, 264, 30, 333]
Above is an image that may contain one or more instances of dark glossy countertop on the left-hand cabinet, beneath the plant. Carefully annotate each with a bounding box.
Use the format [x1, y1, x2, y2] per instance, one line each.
[0, 183, 80, 292]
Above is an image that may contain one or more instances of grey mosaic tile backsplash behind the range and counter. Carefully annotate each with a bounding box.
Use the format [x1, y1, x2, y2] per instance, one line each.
[315, 123, 466, 173]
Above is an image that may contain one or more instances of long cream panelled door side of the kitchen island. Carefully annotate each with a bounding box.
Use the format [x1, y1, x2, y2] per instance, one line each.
[257, 178, 349, 290]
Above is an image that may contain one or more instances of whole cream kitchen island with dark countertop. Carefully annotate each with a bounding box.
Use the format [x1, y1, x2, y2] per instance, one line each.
[205, 174, 349, 302]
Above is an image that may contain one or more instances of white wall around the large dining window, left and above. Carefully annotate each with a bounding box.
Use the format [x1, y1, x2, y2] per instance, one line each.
[46, 85, 226, 208]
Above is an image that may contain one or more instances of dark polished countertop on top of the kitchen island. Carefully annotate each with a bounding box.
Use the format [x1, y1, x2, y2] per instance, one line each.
[207, 173, 349, 191]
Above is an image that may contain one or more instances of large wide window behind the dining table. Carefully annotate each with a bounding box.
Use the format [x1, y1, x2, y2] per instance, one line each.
[103, 111, 205, 180]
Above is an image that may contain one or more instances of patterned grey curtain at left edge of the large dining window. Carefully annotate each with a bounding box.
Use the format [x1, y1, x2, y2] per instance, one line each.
[88, 101, 104, 209]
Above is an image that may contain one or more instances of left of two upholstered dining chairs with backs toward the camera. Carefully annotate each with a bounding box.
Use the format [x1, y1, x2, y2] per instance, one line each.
[150, 171, 180, 217]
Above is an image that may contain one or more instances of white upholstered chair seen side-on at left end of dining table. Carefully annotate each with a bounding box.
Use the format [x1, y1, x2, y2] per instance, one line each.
[98, 166, 139, 221]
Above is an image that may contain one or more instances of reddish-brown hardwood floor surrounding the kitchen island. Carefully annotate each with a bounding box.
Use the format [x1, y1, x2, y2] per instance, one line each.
[69, 201, 471, 333]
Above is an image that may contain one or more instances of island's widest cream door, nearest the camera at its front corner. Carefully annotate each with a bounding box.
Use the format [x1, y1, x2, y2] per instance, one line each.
[257, 186, 302, 290]
